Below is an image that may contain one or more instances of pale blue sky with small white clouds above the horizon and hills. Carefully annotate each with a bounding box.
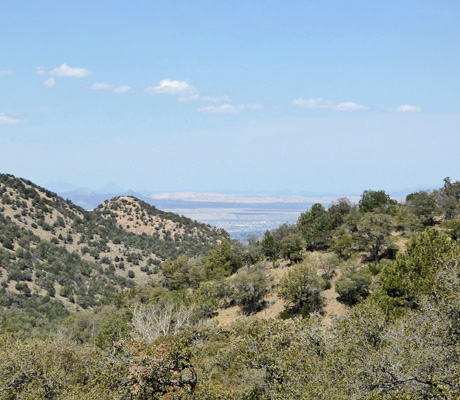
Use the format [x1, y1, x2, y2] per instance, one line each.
[0, 0, 460, 195]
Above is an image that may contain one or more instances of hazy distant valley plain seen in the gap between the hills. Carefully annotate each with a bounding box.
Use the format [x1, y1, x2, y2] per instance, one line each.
[54, 189, 359, 240]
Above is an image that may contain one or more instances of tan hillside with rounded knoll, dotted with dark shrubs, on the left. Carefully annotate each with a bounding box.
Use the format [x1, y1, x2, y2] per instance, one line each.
[0, 174, 228, 332]
